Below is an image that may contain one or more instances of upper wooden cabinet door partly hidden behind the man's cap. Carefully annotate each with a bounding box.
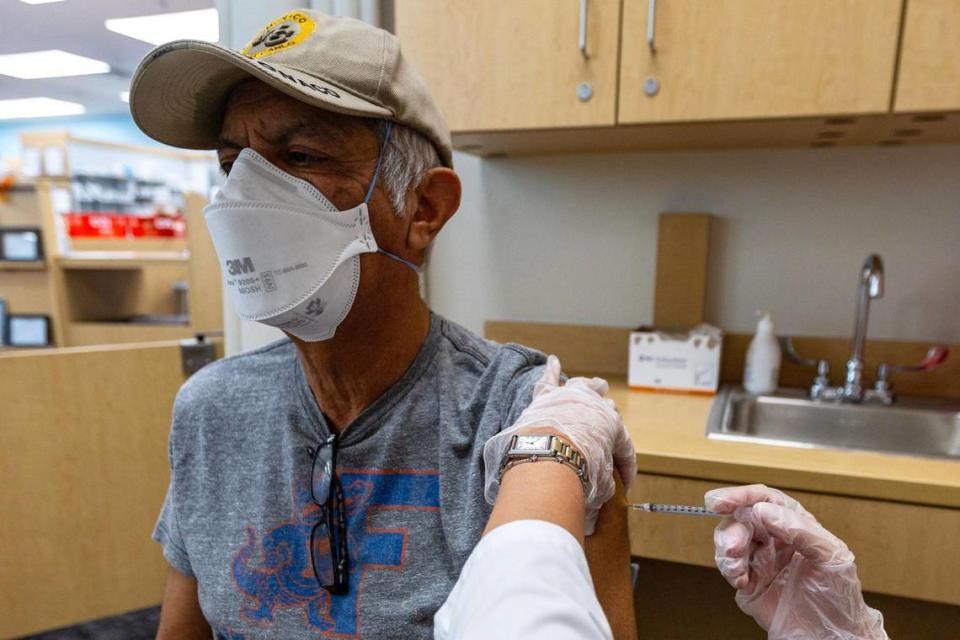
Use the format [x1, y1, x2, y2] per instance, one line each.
[395, 0, 620, 131]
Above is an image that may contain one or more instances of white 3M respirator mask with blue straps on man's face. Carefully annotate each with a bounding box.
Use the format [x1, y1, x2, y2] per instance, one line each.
[203, 123, 418, 342]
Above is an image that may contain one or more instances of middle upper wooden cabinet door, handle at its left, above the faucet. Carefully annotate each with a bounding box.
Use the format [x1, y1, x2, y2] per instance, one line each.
[619, 0, 901, 123]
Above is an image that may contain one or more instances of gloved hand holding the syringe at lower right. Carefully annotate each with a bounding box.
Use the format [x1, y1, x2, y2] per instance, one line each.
[704, 484, 887, 640]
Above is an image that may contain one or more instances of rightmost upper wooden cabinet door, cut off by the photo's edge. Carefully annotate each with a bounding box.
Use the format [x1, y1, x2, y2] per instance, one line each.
[894, 0, 960, 111]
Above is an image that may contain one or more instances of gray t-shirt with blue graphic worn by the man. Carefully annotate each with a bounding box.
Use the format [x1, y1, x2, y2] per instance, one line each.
[153, 314, 546, 640]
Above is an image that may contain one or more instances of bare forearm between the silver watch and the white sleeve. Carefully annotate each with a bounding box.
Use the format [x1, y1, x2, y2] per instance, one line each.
[483, 450, 584, 546]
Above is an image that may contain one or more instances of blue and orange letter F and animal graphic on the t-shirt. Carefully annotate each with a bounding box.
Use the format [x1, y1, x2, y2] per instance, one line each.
[233, 469, 440, 636]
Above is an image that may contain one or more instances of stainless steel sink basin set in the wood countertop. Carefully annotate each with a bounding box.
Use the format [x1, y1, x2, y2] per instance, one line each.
[707, 387, 960, 460]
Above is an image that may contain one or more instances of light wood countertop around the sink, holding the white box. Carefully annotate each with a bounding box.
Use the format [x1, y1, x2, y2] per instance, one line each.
[608, 377, 960, 508]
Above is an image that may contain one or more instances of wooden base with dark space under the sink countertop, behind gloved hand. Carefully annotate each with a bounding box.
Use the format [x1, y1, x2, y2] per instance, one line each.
[628, 474, 960, 640]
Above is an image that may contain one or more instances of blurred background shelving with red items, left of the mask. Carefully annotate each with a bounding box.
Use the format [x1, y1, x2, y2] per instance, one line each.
[0, 132, 223, 346]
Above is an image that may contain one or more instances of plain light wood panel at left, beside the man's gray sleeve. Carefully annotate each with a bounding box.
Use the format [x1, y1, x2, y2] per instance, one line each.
[0, 341, 195, 638]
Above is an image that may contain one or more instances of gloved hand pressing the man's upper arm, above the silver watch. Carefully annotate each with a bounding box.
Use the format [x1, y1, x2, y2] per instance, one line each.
[483, 356, 637, 535]
